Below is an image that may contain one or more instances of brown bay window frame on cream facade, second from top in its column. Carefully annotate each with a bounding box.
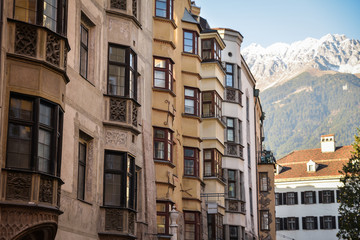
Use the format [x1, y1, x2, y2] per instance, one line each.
[201, 90, 223, 119]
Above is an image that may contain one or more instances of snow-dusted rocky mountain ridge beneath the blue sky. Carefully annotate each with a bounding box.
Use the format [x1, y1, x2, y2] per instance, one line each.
[242, 34, 360, 89]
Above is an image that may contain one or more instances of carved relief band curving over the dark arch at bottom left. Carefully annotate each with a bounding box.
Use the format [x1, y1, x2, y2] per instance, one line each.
[0, 206, 58, 240]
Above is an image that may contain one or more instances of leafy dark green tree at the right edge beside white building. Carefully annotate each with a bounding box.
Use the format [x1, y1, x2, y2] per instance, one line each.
[337, 128, 360, 240]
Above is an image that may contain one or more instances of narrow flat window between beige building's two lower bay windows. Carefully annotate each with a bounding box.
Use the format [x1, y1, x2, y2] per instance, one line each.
[77, 141, 87, 200]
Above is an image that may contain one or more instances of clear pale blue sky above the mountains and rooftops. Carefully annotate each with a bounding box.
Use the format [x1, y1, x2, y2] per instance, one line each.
[195, 0, 360, 47]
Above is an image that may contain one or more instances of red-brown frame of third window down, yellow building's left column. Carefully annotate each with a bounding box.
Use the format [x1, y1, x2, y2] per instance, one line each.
[153, 127, 174, 162]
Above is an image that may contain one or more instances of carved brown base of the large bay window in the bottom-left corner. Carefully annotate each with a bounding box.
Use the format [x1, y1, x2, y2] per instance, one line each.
[0, 169, 63, 240]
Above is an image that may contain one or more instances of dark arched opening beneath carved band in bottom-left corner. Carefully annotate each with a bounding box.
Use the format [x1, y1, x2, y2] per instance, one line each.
[12, 223, 57, 240]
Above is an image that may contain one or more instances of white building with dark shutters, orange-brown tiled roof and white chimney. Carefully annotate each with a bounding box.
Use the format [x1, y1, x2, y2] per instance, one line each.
[275, 134, 353, 239]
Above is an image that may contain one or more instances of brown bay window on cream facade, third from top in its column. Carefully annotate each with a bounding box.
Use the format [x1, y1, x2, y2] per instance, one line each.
[204, 149, 222, 178]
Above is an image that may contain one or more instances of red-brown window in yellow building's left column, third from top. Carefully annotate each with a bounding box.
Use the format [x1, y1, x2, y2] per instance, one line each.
[154, 128, 173, 162]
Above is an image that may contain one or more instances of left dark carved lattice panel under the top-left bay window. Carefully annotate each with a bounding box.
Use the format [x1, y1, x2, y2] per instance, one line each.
[15, 23, 37, 57]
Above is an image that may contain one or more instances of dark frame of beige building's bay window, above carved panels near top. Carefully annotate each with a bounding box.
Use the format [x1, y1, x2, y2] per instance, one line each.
[107, 43, 138, 100]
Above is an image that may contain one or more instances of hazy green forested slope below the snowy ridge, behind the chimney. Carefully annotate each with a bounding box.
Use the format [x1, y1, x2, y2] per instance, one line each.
[261, 73, 360, 158]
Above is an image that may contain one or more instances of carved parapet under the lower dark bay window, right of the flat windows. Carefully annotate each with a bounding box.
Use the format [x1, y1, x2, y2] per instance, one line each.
[98, 207, 136, 240]
